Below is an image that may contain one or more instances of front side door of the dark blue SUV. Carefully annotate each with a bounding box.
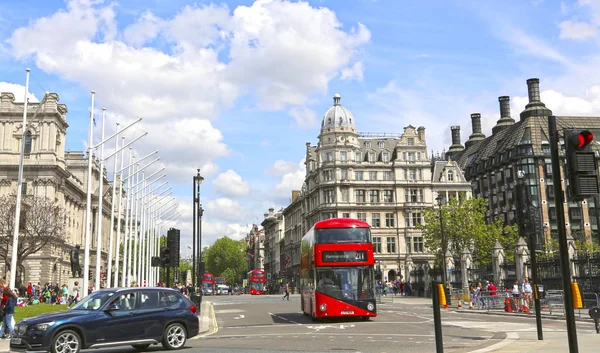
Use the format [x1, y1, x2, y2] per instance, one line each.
[97, 292, 142, 343]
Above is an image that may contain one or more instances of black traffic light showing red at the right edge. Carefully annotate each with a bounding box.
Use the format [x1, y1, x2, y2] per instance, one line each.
[565, 129, 600, 201]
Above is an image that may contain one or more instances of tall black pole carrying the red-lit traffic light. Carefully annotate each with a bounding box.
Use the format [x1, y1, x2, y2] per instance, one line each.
[548, 116, 579, 353]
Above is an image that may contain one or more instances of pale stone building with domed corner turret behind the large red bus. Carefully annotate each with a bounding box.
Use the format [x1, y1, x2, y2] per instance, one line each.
[270, 94, 471, 283]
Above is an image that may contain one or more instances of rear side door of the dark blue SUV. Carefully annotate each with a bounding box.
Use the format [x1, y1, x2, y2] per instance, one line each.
[136, 289, 168, 339]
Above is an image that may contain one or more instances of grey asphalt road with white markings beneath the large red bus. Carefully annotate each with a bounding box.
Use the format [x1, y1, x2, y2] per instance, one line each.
[19, 295, 598, 353]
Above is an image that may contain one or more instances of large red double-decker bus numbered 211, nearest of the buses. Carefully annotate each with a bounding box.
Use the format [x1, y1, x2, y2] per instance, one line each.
[300, 218, 377, 320]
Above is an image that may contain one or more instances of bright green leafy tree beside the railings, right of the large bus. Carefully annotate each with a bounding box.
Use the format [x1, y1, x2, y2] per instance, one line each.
[418, 198, 518, 265]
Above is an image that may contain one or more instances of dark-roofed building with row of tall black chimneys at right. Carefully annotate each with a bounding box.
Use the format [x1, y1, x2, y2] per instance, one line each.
[446, 78, 600, 246]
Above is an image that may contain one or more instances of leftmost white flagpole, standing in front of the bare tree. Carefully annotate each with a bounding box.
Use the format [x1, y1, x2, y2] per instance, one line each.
[9, 68, 31, 289]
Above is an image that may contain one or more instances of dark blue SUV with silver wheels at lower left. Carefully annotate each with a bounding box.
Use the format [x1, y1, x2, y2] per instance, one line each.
[10, 287, 199, 353]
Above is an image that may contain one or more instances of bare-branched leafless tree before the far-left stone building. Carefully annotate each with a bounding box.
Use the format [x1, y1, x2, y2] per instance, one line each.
[0, 194, 66, 282]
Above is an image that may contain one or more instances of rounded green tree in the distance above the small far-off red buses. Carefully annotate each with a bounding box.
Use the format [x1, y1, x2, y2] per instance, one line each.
[203, 237, 246, 283]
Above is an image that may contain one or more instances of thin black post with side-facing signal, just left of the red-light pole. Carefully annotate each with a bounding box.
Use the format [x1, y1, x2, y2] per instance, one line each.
[517, 170, 544, 341]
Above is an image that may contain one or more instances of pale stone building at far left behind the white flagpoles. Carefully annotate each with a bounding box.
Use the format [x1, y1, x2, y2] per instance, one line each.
[0, 92, 123, 284]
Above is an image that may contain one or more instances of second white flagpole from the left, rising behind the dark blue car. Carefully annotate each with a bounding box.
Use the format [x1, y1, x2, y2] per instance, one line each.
[82, 91, 96, 298]
